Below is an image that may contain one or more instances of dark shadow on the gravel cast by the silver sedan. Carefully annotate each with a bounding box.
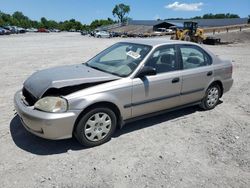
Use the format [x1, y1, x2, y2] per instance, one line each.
[10, 101, 222, 155]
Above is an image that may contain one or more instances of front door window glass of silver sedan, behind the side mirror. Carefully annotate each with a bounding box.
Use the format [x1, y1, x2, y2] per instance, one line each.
[145, 46, 178, 73]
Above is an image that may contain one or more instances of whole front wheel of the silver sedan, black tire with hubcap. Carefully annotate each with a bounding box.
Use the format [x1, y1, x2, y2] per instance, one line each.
[74, 107, 117, 147]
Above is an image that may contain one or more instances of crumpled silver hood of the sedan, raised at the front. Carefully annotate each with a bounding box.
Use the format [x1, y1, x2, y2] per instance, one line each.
[24, 64, 119, 98]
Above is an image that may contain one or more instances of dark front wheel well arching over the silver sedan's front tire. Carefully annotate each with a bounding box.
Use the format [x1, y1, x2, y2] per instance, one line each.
[72, 102, 122, 134]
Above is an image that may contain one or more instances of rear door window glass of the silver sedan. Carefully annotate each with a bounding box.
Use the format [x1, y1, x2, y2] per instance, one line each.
[180, 45, 212, 69]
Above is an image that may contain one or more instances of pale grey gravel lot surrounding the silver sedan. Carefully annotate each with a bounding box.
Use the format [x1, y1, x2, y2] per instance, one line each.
[0, 32, 250, 188]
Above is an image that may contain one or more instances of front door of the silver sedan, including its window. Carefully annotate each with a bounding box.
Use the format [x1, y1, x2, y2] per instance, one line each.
[131, 45, 181, 117]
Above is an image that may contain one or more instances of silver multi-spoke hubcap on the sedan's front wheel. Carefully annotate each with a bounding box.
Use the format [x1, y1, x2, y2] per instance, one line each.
[84, 112, 112, 142]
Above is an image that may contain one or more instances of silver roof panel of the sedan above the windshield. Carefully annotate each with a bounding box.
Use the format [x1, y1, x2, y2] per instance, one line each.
[122, 38, 197, 47]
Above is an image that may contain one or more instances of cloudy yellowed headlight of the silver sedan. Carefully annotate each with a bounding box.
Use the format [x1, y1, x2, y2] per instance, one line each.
[34, 97, 68, 112]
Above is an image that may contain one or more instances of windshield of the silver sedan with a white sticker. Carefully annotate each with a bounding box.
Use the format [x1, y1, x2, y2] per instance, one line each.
[86, 42, 151, 77]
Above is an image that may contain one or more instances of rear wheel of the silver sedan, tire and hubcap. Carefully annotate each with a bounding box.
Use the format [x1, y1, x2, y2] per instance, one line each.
[200, 84, 221, 110]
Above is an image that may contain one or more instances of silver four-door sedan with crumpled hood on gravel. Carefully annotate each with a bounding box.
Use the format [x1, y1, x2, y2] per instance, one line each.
[14, 39, 233, 146]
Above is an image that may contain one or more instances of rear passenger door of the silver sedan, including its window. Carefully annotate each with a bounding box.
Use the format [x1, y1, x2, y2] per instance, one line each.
[177, 44, 214, 104]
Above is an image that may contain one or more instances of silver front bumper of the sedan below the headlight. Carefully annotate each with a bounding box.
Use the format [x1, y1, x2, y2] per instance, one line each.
[14, 91, 81, 140]
